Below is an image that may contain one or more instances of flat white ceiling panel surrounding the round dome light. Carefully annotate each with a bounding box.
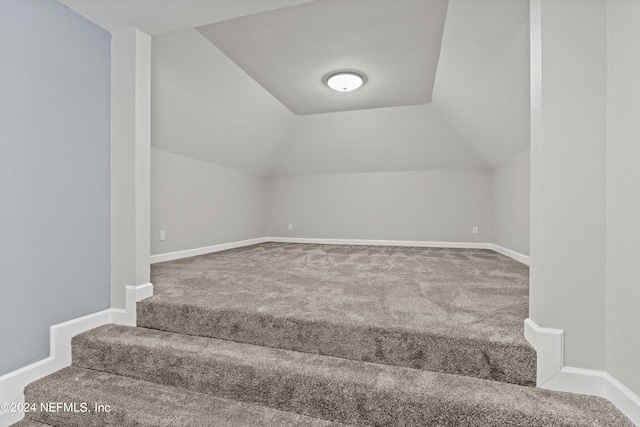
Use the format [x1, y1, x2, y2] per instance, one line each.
[198, 0, 448, 115]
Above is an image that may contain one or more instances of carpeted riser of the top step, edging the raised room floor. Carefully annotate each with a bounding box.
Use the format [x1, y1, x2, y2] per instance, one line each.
[138, 300, 536, 386]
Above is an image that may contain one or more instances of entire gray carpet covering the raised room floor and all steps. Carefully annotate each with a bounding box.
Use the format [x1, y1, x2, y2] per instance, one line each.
[19, 244, 633, 427]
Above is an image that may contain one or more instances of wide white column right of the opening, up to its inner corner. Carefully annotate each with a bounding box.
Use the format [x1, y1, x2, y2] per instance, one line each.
[530, 0, 607, 370]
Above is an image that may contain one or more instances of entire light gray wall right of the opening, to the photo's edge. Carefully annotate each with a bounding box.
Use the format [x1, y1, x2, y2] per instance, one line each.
[530, 0, 640, 402]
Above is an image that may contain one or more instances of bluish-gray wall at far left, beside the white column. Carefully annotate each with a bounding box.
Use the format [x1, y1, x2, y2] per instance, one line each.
[0, 0, 111, 374]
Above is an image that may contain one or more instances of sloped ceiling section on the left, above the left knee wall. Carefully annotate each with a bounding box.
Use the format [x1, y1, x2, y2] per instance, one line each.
[151, 29, 294, 175]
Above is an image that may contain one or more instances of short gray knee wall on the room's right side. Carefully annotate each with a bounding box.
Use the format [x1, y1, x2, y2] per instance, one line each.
[492, 149, 530, 255]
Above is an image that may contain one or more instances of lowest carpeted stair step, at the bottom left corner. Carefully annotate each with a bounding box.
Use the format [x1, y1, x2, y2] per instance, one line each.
[17, 367, 348, 427]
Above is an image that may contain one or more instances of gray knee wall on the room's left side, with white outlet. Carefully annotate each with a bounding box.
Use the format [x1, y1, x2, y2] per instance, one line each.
[151, 148, 266, 255]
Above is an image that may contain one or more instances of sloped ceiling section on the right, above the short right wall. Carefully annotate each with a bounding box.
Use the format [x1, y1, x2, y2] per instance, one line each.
[433, 0, 529, 167]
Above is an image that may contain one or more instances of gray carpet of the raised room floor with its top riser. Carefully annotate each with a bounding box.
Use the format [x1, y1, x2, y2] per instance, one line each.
[138, 243, 536, 386]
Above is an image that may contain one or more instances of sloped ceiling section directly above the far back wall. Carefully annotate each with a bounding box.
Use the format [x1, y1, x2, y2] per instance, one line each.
[272, 104, 484, 175]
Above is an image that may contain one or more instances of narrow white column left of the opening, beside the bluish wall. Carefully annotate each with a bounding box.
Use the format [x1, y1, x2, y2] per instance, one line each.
[111, 28, 151, 308]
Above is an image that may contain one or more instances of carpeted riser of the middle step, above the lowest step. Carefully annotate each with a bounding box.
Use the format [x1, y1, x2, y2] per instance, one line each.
[73, 336, 549, 426]
